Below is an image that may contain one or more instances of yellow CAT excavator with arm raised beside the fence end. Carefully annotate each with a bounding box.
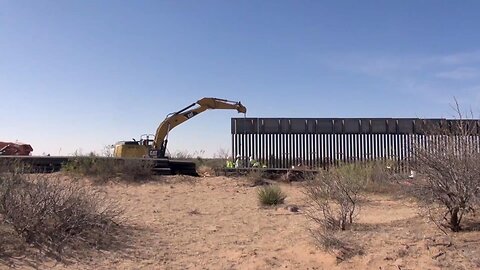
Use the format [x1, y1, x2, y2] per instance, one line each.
[114, 98, 247, 159]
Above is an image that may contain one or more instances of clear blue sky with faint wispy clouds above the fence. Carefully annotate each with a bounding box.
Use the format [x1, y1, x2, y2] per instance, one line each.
[0, 0, 480, 155]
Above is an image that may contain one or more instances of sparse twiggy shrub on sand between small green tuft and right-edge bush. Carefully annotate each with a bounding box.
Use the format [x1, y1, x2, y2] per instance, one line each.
[304, 165, 364, 260]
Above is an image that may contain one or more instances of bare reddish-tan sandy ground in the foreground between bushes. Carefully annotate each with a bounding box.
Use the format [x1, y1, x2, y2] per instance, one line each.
[0, 176, 480, 269]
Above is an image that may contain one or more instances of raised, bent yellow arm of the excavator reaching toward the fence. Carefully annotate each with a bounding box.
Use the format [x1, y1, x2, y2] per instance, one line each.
[150, 98, 247, 157]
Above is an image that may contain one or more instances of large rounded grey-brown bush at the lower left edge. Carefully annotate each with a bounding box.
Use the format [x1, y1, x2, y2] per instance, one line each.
[0, 174, 122, 258]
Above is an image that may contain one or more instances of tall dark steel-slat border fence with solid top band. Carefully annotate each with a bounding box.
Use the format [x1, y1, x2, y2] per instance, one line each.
[231, 118, 480, 168]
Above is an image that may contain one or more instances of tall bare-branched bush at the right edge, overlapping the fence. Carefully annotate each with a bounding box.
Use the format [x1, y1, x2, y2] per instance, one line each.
[414, 103, 480, 232]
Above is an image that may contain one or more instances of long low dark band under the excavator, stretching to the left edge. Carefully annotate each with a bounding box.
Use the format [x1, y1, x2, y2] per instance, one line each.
[0, 156, 198, 176]
